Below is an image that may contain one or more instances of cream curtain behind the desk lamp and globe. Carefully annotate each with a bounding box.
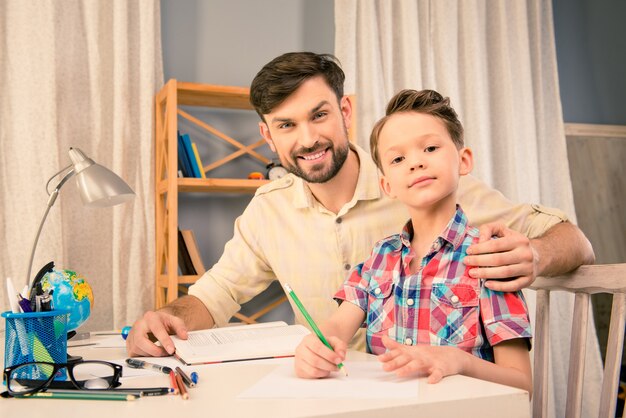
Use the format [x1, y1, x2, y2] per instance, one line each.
[0, 0, 163, 331]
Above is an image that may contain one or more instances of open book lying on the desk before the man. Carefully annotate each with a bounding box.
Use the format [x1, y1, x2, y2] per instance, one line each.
[172, 321, 309, 365]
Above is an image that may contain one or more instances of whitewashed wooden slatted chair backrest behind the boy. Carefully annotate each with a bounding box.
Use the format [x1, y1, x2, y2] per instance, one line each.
[531, 264, 626, 418]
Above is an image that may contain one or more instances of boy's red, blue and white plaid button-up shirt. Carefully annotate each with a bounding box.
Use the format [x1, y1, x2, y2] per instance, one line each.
[335, 206, 532, 361]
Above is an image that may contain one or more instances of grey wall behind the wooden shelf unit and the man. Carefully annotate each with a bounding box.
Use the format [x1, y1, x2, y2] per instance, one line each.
[161, 0, 335, 321]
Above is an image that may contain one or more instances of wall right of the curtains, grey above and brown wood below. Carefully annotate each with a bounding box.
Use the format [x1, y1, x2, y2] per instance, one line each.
[553, 0, 626, 366]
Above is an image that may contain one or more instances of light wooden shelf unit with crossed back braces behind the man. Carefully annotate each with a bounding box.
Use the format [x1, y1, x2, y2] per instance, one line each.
[155, 79, 270, 309]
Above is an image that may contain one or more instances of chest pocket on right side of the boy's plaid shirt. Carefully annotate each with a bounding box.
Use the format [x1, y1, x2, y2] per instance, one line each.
[430, 280, 480, 348]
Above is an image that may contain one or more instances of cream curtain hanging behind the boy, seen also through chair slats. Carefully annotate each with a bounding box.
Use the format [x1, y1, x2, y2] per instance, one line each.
[335, 0, 601, 417]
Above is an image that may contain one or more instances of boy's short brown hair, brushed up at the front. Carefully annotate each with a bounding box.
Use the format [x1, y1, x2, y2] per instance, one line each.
[370, 89, 464, 171]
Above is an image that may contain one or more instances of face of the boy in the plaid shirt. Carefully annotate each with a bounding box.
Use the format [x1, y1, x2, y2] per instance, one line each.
[378, 112, 472, 209]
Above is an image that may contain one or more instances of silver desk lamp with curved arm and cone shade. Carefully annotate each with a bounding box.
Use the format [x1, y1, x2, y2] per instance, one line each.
[26, 148, 135, 294]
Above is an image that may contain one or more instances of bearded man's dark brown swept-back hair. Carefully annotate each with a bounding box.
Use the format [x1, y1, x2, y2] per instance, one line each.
[250, 52, 345, 121]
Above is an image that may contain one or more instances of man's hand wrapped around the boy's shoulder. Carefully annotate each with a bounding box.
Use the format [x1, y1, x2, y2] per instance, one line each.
[465, 222, 539, 292]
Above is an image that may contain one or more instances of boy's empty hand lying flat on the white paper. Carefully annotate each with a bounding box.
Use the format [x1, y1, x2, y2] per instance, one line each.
[378, 336, 463, 383]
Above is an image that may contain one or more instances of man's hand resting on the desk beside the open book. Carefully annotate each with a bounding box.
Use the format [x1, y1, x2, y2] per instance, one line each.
[126, 311, 187, 357]
